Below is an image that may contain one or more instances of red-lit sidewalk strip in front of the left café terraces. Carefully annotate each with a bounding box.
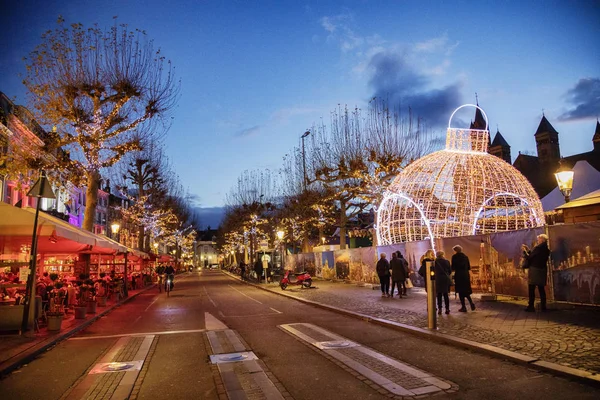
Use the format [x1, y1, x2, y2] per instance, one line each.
[0, 285, 156, 377]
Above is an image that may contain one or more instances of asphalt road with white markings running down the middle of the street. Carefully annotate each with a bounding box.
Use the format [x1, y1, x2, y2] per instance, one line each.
[0, 270, 600, 400]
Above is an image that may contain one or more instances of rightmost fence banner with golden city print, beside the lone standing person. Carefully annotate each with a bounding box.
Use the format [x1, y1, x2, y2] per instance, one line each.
[548, 222, 600, 305]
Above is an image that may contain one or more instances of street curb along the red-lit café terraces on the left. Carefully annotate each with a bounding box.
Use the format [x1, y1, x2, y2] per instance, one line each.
[0, 284, 156, 378]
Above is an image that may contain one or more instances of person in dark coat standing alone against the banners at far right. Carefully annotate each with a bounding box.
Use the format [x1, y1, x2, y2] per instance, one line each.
[525, 234, 550, 312]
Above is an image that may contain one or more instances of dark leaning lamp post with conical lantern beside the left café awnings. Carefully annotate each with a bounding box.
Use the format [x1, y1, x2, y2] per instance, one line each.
[21, 170, 56, 333]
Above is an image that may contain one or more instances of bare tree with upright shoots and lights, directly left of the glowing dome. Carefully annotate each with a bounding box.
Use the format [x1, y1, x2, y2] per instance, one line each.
[309, 98, 435, 249]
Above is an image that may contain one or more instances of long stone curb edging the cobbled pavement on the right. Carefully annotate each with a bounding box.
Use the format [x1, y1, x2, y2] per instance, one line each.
[223, 271, 600, 386]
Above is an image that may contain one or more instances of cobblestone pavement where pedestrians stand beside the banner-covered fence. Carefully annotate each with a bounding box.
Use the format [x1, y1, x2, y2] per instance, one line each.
[260, 281, 600, 373]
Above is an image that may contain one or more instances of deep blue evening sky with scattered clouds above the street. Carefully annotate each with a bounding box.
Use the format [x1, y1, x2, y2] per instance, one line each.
[0, 0, 600, 207]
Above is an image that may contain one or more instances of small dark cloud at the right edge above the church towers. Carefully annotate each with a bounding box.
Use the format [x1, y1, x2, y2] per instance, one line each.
[558, 78, 600, 121]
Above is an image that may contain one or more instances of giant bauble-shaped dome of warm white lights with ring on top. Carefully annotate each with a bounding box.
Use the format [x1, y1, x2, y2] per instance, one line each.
[377, 104, 544, 247]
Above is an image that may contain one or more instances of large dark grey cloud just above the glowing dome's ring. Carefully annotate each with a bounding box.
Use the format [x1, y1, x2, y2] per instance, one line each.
[369, 52, 461, 127]
